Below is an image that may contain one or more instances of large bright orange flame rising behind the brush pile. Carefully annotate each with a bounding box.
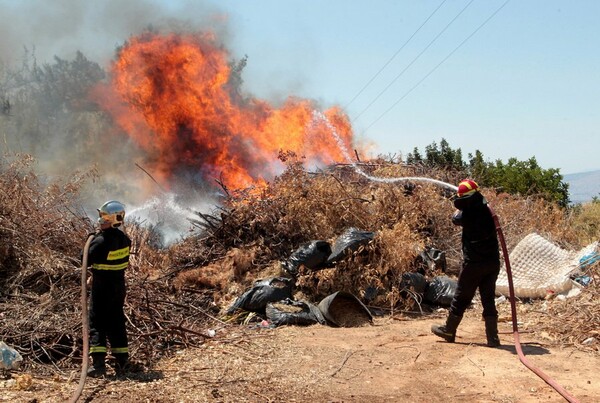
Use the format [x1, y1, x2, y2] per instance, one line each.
[97, 33, 352, 188]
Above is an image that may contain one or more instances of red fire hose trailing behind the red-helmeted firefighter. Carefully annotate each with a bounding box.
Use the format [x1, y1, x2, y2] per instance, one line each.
[488, 204, 579, 403]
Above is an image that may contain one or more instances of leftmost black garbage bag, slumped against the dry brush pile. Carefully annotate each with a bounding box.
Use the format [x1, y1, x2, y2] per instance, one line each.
[227, 277, 293, 314]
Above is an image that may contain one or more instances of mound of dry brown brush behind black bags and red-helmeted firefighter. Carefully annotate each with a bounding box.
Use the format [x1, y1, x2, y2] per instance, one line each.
[172, 161, 581, 307]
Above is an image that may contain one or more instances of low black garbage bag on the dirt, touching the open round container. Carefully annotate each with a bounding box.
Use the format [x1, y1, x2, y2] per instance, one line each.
[265, 298, 326, 326]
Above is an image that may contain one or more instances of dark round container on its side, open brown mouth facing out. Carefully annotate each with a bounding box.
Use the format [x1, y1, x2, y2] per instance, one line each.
[319, 291, 373, 327]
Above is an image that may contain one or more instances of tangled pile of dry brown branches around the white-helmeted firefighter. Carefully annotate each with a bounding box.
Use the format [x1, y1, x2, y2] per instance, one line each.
[0, 156, 221, 372]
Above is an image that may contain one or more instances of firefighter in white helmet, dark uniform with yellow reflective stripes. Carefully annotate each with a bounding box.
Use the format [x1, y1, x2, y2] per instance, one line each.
[87, 200, 131, 377]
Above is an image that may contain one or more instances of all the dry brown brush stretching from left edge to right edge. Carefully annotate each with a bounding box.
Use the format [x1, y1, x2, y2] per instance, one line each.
[0, 156, 600, 378]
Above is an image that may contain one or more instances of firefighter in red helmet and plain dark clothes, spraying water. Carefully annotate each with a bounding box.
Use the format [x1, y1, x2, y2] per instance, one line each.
[431, 179, 500, 347]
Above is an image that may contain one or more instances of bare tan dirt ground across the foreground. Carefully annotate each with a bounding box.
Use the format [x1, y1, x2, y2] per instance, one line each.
[0, 311, 600, 402]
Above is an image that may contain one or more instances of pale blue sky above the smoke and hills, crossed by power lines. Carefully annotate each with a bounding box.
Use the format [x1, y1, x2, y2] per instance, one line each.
[0, 0, 600, 174]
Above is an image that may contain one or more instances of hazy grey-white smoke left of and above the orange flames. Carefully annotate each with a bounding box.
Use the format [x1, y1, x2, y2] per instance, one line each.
[0, 0, 230, 244]
